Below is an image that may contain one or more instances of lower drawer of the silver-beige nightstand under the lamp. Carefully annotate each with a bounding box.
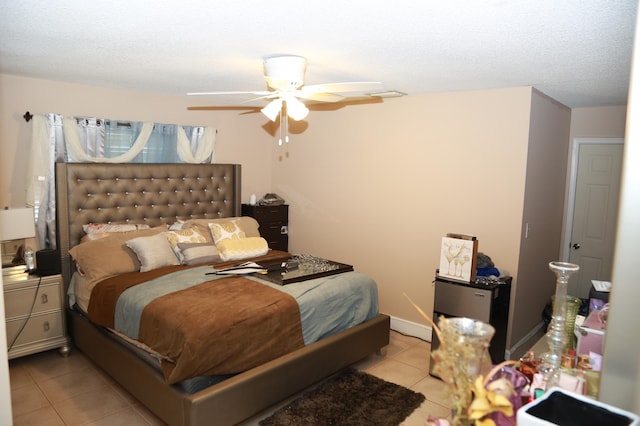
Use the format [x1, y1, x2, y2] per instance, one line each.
[6, 311, 64, 349]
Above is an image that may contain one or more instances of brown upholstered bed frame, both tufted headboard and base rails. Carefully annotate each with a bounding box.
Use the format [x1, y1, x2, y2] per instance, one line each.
[56, 163, 389, 426]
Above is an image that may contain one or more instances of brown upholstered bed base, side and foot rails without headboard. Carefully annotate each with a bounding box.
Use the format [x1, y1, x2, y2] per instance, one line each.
[69, 311, 389, 426]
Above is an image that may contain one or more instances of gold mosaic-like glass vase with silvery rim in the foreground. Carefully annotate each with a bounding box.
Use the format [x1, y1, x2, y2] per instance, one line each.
[432, 317, 495, 426]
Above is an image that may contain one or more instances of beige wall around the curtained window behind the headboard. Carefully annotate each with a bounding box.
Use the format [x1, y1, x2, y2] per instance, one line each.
[0, 74, 272, 207]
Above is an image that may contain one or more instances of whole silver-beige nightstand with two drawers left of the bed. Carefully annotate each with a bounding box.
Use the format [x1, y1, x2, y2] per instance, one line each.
[3, 274, 71, 359]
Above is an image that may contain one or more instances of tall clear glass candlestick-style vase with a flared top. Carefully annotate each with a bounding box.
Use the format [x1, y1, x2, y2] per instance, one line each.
[540, 262, 580, 389]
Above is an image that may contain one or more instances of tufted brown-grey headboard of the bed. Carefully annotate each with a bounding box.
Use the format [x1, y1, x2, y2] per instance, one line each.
[56, 163, 241, 291]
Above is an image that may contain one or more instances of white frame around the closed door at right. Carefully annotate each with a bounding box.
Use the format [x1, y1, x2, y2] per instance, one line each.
[560, 138, 624, 262]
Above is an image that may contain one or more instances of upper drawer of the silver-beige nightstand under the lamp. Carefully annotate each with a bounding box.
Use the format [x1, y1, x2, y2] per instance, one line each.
[4, 283, 62, 319]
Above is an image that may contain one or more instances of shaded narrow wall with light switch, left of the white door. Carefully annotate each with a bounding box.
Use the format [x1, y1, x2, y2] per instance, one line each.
[508, 91, 571, 345]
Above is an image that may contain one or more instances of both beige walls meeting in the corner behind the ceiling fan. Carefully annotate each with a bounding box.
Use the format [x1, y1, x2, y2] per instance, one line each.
[0, 75, 532, 342]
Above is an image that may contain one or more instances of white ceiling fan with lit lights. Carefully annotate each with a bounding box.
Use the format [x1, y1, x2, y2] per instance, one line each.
[187, 55, 383, 142]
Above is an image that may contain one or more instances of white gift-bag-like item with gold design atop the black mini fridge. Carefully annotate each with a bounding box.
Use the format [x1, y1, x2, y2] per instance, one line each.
[438, 234, 478, 283]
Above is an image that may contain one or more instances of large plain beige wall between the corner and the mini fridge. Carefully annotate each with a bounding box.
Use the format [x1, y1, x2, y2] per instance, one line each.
[273, 88, 531, 332]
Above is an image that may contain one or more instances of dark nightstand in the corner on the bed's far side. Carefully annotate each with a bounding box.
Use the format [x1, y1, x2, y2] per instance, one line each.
[242, 204, 289, 251]
